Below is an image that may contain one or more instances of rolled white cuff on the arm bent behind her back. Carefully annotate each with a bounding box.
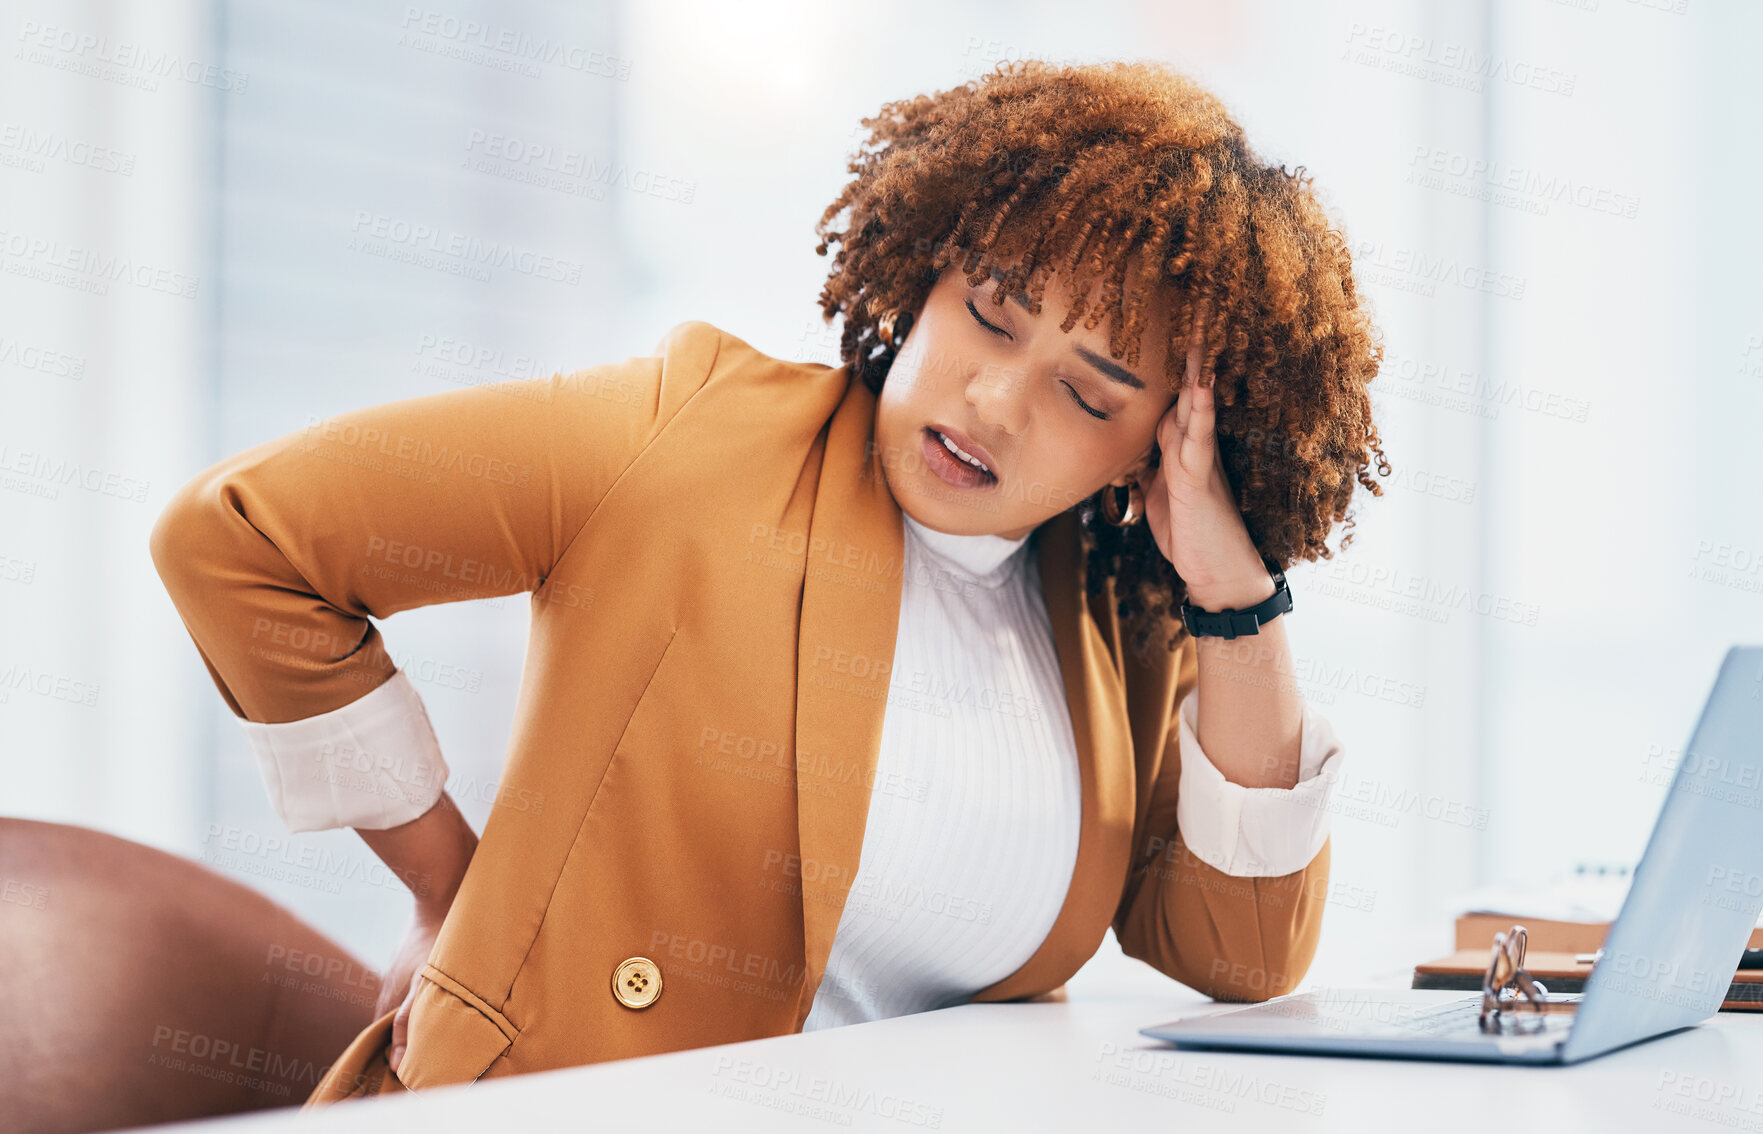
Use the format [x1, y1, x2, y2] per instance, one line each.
[240, 670, 448, 832]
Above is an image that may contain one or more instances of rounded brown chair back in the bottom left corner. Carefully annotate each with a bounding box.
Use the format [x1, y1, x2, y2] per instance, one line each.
[0, 817, 379, 1132]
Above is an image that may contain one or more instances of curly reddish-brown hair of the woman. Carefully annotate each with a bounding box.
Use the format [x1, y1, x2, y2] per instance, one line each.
[815, 60, 1389, 653]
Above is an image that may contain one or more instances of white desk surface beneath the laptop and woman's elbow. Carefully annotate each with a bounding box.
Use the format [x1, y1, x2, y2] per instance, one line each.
[130, 935, 1763, 1134]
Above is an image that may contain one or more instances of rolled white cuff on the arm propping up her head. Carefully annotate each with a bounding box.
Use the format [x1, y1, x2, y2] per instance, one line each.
[1176, 688, 1342, 878]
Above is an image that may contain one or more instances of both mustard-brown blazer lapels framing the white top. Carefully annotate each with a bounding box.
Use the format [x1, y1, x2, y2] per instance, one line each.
[795, 381, 1134, 1028]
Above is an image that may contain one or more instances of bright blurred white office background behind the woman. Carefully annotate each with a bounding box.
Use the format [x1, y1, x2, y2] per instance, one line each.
[0, 0, 1763, 965]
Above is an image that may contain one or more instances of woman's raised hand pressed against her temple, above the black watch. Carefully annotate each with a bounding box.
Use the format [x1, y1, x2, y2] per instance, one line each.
[1142, 298, 1275, 610]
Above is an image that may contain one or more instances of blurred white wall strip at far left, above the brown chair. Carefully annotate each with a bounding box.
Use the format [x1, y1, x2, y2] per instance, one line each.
[0, 4, 220, 847]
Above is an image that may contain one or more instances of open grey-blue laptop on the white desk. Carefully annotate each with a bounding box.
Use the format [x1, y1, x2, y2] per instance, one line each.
[1139, 645, 1763, 1063]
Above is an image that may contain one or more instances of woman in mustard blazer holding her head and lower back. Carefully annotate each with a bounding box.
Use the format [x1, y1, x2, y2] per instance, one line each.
[152, 62, 1389, 1104]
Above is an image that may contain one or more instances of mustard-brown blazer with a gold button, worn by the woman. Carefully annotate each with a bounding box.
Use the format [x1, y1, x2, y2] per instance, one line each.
[152, 321, 1329, 1106]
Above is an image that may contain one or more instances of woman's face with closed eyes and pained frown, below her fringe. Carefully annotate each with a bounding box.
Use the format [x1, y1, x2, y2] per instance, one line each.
[876, 263, 1176, 540]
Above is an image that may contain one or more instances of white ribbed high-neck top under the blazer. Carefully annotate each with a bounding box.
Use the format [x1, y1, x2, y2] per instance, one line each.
[802, 515, 1082, 1032]
